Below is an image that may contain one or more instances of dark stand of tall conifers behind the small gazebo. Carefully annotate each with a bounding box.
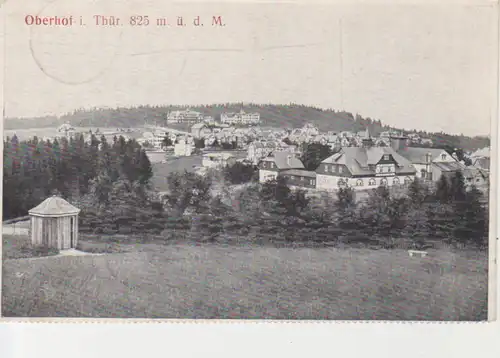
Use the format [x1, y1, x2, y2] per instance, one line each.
[3, 135, 153, 219]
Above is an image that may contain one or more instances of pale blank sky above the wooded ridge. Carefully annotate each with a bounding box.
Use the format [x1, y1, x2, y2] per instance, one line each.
[1, 0, 498, 135]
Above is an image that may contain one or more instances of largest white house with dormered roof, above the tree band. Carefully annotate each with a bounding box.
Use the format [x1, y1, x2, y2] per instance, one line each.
[316, 142, 416, 191]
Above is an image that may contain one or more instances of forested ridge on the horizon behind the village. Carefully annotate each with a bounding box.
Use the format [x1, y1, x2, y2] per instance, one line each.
[4, 103, 490, 151]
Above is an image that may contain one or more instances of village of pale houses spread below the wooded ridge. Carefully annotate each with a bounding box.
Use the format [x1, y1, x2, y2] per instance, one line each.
[45, 108, 489, 196]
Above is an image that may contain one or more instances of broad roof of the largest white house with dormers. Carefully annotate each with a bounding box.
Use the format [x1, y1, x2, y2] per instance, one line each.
[322, 147, 416, 176]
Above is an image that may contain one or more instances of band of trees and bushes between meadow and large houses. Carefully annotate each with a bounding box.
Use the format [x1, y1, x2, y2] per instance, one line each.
[81, 163, 488, 248]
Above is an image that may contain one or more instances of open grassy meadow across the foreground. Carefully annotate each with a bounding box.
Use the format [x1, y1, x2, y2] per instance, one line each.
[2, 244, 487, 320]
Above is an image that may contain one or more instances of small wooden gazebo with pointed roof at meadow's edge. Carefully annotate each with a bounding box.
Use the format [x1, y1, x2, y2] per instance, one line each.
[29, 195, 80, 250]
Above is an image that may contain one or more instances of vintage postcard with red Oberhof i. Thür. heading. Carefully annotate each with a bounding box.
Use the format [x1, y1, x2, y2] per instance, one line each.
[1, 0, 499, 322]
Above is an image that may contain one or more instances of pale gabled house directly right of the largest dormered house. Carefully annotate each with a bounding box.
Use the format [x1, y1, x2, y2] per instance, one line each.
[398, 146, 464, 181]
